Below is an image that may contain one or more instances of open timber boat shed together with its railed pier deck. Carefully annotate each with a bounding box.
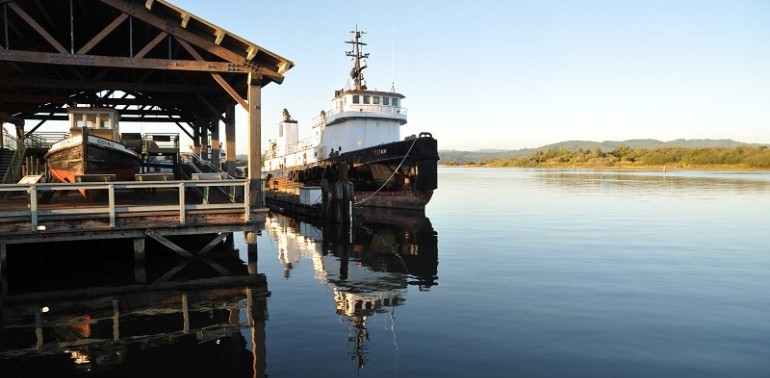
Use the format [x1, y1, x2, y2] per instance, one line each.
[0, 0, 294, 305]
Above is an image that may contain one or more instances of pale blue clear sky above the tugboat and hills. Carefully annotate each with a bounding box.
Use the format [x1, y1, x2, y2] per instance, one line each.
[170, 0, 770, 154]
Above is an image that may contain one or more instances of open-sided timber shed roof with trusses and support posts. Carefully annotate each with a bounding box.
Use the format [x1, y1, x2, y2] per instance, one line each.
[0, 0, 294, 208]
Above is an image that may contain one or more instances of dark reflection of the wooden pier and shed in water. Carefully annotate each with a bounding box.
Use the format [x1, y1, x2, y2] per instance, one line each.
[0, 239, 269, 378]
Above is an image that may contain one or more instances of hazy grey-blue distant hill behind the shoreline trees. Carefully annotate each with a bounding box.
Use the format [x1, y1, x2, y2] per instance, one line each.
[438, 139, 759, 164]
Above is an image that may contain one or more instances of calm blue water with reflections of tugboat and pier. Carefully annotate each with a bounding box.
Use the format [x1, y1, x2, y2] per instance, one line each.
[0, 168, 770, 378]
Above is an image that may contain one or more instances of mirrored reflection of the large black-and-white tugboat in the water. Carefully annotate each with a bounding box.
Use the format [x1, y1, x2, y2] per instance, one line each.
[265, 209, 438, 369]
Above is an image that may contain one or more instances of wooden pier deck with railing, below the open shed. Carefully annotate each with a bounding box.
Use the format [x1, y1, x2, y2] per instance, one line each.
[0, 179, 268, 256]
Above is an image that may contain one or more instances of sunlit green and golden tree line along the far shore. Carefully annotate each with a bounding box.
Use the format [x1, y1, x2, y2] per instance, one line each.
[443, 145, 770, 169]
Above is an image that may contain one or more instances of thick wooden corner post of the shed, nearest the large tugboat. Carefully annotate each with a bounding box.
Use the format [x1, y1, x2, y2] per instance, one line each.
[248, 71, 263, 211]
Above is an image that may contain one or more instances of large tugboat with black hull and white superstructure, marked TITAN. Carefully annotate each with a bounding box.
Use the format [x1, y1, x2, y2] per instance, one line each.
[262, 28, 439, 211]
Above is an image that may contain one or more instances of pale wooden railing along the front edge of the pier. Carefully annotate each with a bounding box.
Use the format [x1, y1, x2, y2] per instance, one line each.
[0, 179, 251, 230]
